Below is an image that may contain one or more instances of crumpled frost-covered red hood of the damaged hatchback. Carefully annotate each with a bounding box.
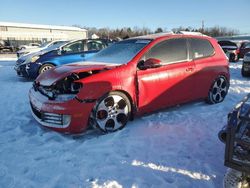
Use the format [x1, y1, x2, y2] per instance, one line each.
[36, 61, 119, 86]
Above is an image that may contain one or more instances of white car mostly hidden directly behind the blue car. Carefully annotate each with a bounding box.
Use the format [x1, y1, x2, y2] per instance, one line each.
[17, 40, 68, 58]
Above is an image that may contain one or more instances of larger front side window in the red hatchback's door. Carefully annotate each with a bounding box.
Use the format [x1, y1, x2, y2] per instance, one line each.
[145, 38, 187, 64]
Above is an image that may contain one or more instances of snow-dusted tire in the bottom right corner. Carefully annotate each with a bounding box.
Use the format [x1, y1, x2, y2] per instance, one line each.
[223, 169, 250, 188]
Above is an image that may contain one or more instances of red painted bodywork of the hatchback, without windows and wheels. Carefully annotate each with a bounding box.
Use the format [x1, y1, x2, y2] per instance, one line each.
[29, 34, 229, 133]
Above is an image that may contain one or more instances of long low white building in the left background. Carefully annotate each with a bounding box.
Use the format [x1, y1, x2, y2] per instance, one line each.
[0, 22, 88, 45]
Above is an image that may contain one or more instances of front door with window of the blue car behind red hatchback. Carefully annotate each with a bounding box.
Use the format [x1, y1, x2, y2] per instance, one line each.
[57, 40, 84, 64]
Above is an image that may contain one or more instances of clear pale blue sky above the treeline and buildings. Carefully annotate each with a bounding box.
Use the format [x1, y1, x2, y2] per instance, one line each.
[0, 0, 250, 34]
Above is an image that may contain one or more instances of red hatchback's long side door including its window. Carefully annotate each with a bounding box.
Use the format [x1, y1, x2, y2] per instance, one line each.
[137, 38, 195, 113]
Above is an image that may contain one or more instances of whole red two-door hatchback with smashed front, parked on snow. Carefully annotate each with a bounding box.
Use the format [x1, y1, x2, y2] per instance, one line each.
[29, 33, 229, 133]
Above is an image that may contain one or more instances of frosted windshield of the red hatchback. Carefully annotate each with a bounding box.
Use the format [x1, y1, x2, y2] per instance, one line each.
[87, 39, 152, 64]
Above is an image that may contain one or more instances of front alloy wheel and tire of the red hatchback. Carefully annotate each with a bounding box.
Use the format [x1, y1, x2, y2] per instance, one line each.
[91, 91, 131, 133]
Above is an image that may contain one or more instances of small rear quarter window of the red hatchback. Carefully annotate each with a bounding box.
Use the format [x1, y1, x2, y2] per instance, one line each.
[189, 38, 214, 59]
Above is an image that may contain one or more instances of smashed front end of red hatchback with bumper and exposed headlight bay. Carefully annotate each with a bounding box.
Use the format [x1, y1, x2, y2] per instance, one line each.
[30, 71, 101, 132]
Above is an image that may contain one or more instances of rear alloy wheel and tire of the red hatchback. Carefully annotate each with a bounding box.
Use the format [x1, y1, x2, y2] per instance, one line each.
[206, 76, 229, 104]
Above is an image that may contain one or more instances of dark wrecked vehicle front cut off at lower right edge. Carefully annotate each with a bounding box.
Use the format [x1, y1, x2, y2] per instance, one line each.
[220, 95, 250, 174]
